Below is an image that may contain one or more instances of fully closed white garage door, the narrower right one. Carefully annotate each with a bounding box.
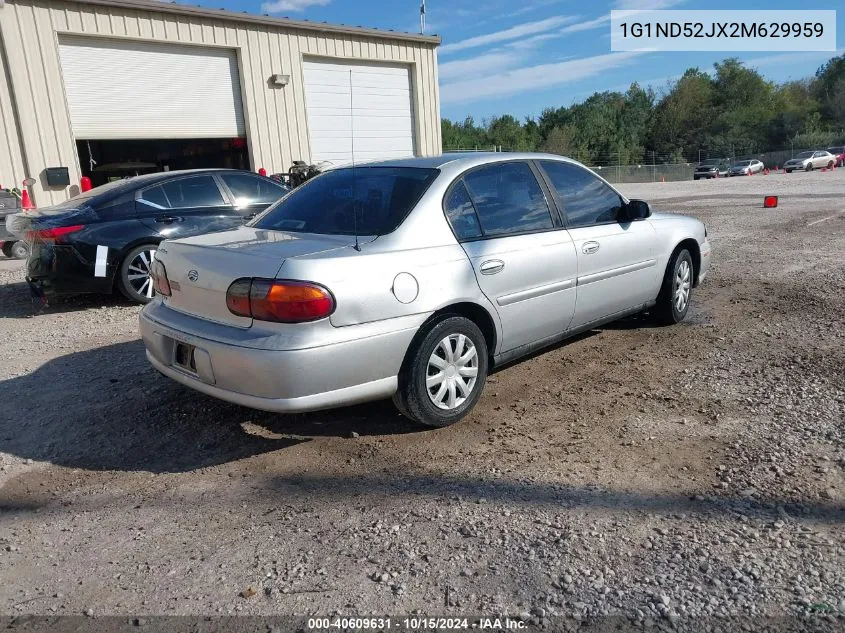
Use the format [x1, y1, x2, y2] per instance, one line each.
[304, 62, 414, 165]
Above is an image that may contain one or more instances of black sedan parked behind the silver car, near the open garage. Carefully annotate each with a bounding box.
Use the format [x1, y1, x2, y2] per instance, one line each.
[7, 169, 289, 303]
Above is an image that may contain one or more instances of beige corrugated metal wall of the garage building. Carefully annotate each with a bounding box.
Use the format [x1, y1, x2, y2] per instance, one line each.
[0, 0, 441, 206]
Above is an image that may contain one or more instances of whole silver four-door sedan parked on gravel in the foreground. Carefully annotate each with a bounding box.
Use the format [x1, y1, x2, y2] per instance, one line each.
[140, 153, 710, 426]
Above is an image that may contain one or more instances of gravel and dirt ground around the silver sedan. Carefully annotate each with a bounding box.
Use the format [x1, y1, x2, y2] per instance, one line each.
[0, 170, 845, 630]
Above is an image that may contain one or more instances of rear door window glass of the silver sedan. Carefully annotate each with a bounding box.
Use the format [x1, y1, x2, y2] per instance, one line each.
[463, 163, 554, 237]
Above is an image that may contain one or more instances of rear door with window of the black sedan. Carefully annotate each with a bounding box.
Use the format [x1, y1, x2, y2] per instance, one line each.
[135, 173, 243, 239]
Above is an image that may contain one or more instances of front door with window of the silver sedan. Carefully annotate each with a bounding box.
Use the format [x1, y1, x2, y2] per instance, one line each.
[538, 160, 663, 328]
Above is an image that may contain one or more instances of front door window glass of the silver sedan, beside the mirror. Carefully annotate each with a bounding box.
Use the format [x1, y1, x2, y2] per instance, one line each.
[540, 160, 622, 228]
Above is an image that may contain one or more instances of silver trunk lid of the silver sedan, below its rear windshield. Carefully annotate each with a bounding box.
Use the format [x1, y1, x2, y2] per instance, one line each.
[156, 227, 354, 328]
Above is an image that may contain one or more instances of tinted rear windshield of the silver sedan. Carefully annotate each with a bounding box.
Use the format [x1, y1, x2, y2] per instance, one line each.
[250, 167, 439, 235]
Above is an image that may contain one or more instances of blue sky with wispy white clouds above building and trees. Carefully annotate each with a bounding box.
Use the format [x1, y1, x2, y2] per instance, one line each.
[200, 0, 845, 122]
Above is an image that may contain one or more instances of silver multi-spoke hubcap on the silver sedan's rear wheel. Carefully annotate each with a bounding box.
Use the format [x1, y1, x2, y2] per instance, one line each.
[425, 334, 478, 411]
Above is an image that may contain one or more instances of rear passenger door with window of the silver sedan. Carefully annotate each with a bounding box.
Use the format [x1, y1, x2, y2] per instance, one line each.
[444, 161, 577, 352]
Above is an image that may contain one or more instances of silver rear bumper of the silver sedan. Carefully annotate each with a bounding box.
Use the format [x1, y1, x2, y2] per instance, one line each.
[140, 302, 424, 413]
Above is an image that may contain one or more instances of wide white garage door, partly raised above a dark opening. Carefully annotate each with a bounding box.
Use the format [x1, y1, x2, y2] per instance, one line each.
[59, 37, 245, 139]
